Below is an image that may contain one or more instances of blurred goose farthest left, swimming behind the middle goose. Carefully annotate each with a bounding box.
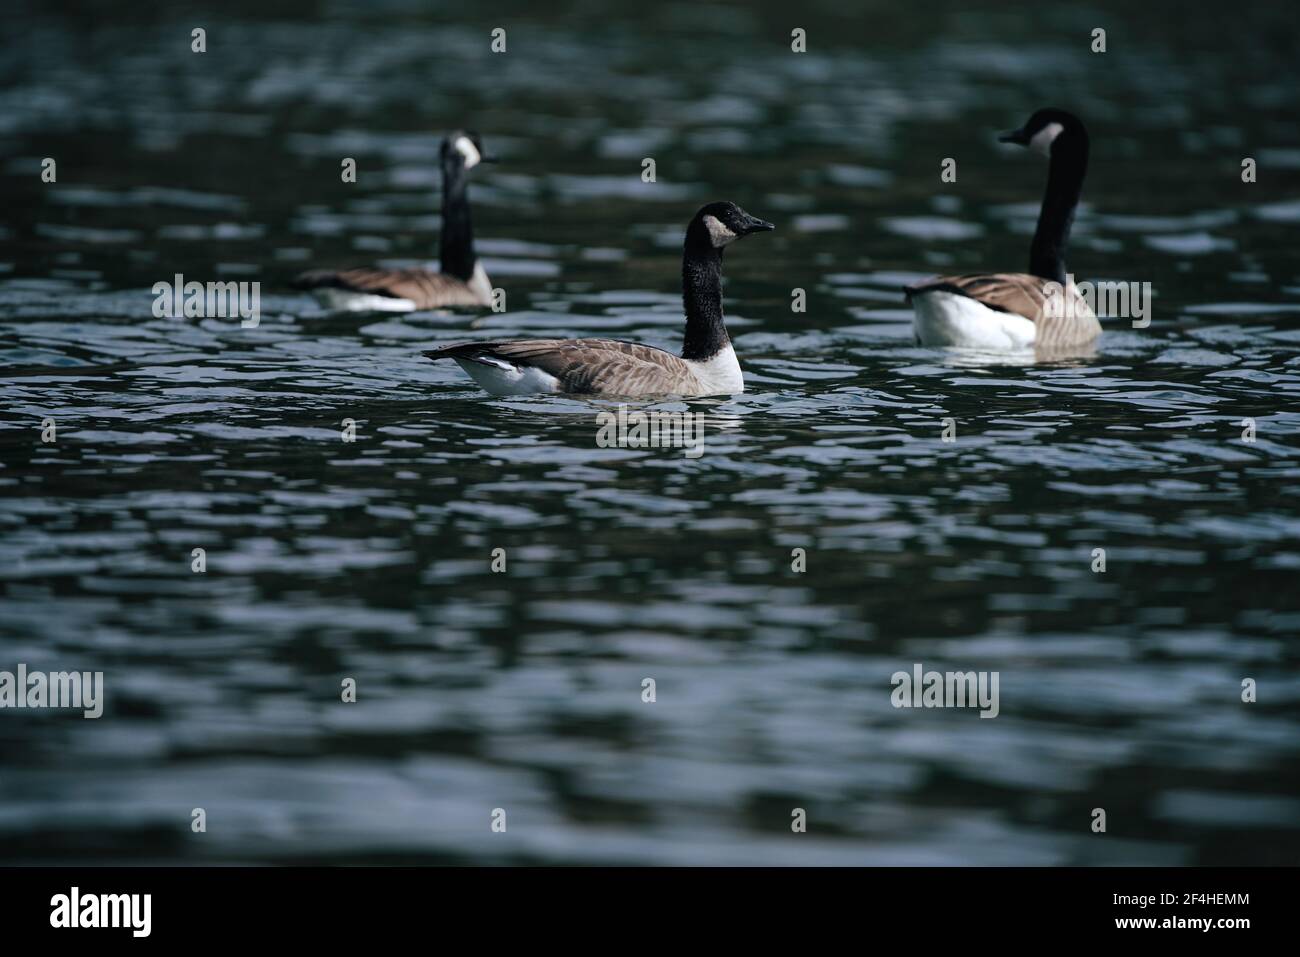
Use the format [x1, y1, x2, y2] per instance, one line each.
[293, 130, 495, 312]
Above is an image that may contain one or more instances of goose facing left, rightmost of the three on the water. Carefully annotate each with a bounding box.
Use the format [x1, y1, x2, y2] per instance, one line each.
[905, 109, 1101, 350]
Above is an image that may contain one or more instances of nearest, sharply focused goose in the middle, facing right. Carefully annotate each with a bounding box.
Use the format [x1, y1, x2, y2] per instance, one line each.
[425, 203, 775, 395]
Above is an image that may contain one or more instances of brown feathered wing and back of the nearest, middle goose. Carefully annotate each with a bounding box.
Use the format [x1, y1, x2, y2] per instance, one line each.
[425, 339, 698, 395]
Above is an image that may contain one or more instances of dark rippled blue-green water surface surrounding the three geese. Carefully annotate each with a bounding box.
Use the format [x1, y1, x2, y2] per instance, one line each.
[0, 3, 1300, 865]
